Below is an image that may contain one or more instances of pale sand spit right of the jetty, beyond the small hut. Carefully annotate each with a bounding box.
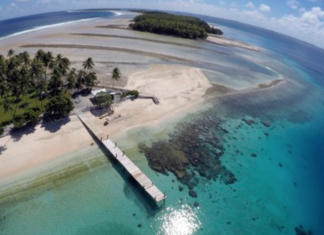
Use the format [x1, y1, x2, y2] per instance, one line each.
[83, 65, 212, 140]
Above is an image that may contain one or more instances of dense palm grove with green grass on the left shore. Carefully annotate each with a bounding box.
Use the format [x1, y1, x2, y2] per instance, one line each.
[0, 49, 97, 128]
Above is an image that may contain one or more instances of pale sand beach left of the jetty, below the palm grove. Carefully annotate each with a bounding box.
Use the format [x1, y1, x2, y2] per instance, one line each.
[0, 116, 94, 186]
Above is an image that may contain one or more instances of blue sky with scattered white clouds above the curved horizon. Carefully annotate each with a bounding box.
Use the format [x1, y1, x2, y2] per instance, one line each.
[0, 0, 324, 48]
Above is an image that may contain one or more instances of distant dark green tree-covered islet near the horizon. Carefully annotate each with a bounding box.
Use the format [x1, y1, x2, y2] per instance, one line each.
[129, 12, 223, 39]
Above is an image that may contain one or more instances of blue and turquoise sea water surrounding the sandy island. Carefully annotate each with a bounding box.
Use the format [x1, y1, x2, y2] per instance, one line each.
[0, 12, 324, 235]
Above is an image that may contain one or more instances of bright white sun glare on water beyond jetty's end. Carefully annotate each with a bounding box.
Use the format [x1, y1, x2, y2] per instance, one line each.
[159, 205, 201, 235]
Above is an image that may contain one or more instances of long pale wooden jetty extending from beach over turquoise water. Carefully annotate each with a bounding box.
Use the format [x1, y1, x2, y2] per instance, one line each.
[78, 115, 166, 205]
